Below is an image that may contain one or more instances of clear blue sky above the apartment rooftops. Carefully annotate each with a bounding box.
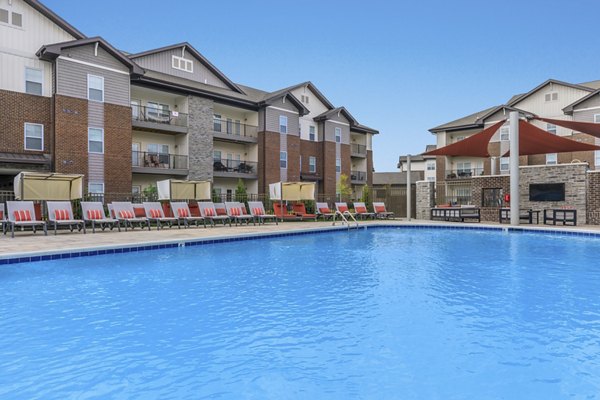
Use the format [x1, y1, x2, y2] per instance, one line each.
[43, 0, 600, 172]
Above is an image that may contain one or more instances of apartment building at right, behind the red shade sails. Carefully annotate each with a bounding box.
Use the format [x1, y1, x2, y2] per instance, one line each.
[429, 79, 600, 202]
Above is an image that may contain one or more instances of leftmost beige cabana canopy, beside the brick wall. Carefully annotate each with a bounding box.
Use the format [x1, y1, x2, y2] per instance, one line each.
[14, 172, 83, 201]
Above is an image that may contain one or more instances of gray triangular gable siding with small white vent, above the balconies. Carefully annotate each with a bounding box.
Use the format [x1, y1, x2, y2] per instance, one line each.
[134, 49, 229, 89]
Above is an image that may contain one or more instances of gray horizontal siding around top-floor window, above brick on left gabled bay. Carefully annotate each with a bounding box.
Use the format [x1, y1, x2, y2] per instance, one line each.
[56, 59, 129, 106]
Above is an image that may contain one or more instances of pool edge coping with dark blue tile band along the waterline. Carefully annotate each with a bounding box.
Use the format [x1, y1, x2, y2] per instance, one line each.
[0, 221, 600, 265]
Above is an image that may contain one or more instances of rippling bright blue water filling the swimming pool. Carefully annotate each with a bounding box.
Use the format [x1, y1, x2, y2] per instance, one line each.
[0, 229, 600, 399]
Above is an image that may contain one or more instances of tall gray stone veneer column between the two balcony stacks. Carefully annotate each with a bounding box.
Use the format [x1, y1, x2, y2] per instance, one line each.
[188, 96, 214, 181]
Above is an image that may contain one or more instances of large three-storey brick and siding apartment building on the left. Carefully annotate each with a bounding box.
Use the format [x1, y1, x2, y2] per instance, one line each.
[0, 0, 378, 199]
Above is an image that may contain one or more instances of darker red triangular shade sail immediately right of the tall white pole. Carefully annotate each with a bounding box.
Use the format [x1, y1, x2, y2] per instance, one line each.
[504, 118, 600, 157]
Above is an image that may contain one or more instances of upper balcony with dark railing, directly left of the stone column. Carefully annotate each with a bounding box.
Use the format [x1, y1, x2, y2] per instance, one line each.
[131, 105, 188, 133]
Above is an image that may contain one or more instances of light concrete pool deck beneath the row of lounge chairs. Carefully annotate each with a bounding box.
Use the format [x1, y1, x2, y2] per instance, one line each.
[0, 219, 600, 260]
